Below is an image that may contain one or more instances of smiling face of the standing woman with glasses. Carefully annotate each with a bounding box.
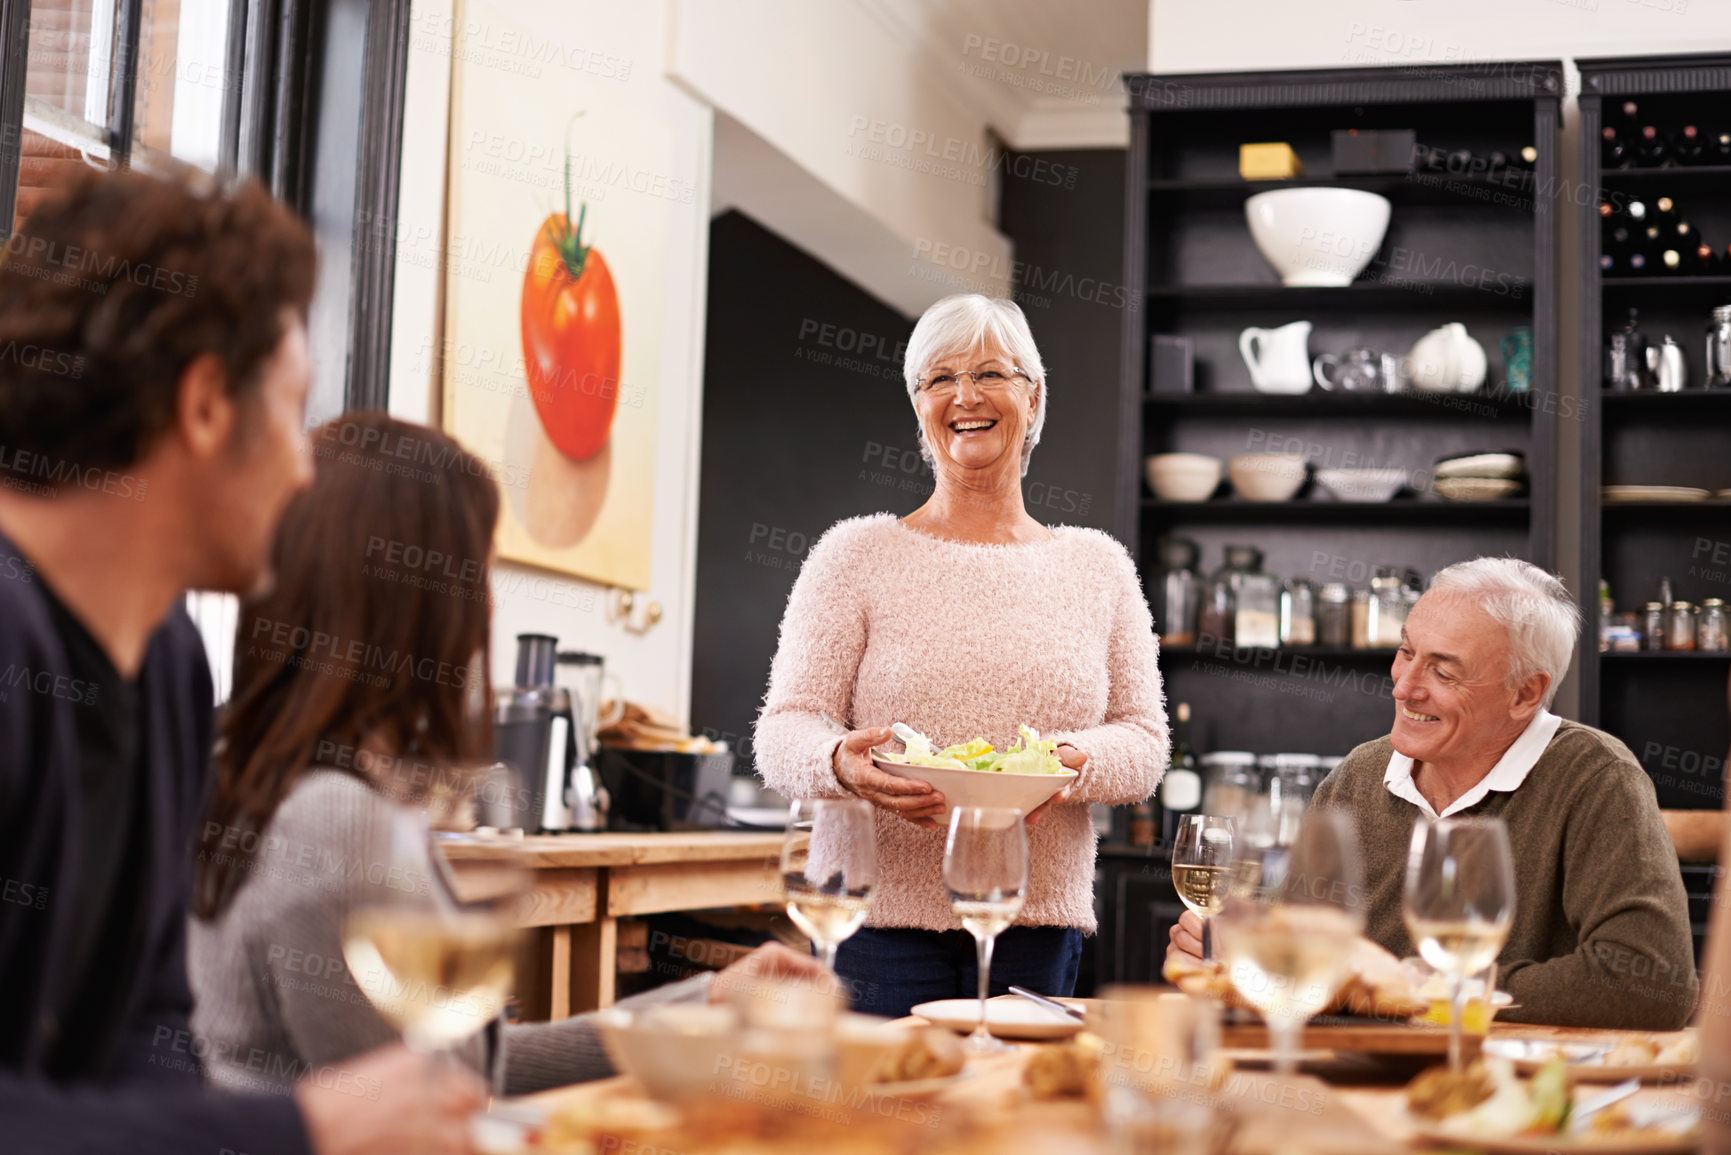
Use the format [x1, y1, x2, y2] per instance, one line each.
[914, 341, 1037, 478]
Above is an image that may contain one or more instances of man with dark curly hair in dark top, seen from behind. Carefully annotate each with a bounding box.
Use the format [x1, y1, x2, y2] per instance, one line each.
[0, 173, 479, 1155]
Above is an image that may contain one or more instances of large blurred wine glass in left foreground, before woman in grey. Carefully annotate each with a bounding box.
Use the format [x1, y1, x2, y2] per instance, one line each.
[343, 764, 531, 1055]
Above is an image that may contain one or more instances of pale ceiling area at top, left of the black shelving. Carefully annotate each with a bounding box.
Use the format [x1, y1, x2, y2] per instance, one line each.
[860, 0, 1149, 149]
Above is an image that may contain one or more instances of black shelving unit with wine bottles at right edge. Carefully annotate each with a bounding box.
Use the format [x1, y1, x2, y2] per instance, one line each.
[1577, 54, 1731, 809]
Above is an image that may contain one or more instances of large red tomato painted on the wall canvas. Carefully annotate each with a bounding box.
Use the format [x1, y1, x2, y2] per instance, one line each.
[523, 213, 620, 461]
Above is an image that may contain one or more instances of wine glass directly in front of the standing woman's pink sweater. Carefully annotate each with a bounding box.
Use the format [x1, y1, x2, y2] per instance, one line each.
[943, 807, 1028, 1051]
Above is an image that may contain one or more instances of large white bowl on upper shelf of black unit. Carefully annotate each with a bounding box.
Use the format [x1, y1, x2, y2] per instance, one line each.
[1245, 189, 1388, 287]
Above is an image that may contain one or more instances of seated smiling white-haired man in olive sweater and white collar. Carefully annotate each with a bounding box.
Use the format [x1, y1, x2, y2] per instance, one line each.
[1172, 558, 1696, 1030]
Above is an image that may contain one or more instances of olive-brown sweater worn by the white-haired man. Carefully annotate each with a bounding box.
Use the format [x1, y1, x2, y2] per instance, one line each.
[1314, 720, 1696, 1030]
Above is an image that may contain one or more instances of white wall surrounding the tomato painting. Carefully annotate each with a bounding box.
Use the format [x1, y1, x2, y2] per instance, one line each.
[389, 0, 713, 719]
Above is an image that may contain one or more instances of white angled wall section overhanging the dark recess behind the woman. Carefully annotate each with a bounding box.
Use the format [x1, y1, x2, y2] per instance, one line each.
[668, 0, 1011, 313]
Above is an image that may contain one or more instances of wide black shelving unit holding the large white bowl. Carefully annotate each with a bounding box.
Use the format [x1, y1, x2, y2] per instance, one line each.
[1115, 62, 1563, 768]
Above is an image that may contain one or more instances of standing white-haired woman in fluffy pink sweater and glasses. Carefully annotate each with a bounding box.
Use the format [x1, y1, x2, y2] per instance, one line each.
[755, 294, 1168, 1015]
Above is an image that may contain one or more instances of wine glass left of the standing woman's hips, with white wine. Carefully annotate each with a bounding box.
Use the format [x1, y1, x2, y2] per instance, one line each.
[781, 798, 878, 971]
